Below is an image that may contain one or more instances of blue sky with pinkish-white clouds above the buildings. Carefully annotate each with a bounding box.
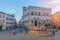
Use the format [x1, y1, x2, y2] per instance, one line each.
[0, 0, 60, 20]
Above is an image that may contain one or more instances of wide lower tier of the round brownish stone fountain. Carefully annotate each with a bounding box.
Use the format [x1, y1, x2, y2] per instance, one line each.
[25, 31, 53, 37]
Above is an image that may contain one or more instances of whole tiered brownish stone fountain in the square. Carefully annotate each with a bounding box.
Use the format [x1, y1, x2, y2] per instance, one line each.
[25, 26, 53, 37]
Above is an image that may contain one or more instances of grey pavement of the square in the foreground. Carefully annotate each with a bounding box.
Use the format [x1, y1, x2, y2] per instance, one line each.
[0, 32, 60, 40]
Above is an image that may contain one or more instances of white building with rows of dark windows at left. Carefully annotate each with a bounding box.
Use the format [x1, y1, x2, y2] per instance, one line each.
[0, 12, 16, 29]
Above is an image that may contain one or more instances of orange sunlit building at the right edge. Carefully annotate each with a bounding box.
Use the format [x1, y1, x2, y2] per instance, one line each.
[51, 11, 60, 28]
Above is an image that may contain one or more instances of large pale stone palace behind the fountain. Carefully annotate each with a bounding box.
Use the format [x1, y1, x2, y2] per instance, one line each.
[21, 6, 51, 27]
